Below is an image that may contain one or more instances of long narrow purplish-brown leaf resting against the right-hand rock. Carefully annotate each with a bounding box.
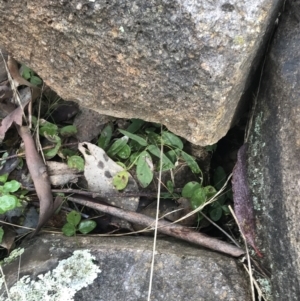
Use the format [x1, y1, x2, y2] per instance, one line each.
[232, 144, 262, 257]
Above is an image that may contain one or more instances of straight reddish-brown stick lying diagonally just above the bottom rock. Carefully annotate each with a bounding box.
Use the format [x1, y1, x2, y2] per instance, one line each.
[68, 197, 245, 257]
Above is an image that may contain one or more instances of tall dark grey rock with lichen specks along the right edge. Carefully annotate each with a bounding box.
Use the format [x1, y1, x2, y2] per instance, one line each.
[248, 8, 300, 301]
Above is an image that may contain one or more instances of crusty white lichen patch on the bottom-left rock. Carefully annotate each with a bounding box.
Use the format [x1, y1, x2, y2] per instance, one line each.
[0, 250, 101, 301]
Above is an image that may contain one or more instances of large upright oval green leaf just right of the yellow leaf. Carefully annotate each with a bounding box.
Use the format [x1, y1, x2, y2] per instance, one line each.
[136, 151, 153, 188]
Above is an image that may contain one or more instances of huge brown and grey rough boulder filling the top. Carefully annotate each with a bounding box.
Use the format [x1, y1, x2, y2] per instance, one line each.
[0, 0, 282, 145]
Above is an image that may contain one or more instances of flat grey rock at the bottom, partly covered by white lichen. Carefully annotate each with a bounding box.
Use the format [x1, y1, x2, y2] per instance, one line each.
[0, 235, 250, 301]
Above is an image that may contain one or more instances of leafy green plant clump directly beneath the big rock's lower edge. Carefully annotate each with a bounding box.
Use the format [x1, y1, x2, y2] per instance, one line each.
[97, 119, 202, 190]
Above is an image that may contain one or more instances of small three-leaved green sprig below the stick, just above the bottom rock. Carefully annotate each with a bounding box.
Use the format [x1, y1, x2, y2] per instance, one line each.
[62, 210, 97, 236]
